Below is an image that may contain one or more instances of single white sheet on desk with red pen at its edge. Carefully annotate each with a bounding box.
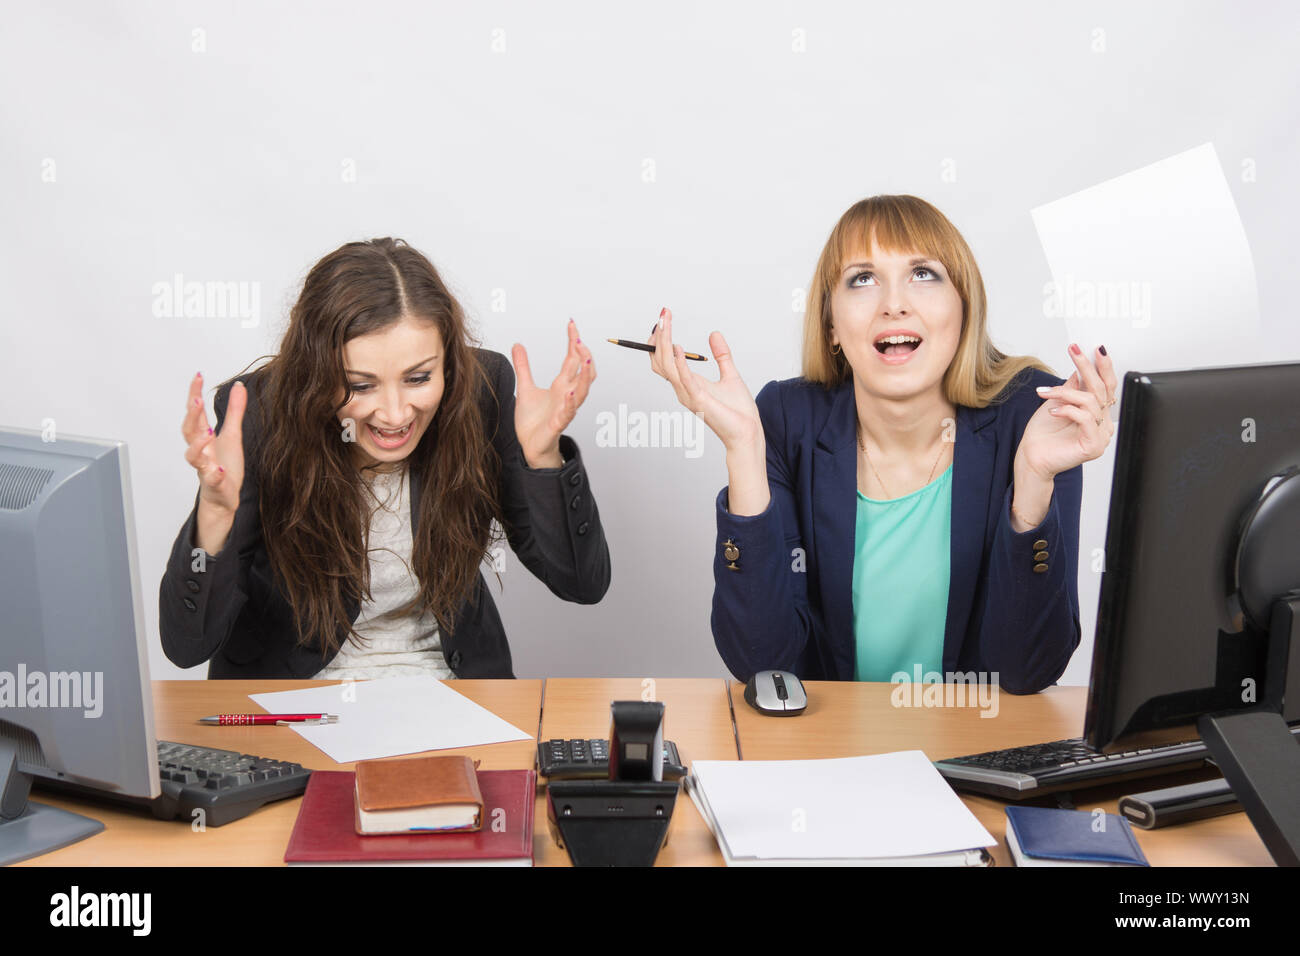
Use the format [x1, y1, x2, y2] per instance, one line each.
[248, 676, 532, 763]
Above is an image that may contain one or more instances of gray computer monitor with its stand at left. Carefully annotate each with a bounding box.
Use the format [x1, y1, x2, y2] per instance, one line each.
[0, 428, 160, 864]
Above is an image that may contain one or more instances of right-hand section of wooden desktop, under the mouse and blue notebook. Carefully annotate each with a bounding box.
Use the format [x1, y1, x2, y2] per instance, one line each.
[731, 680, 1273, 866]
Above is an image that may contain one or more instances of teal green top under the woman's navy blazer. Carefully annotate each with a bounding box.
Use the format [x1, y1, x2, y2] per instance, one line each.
[853, 466, 953, 682]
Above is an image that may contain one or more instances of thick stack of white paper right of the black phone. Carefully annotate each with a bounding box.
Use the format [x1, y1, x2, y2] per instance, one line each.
[690, 750, 996, 860]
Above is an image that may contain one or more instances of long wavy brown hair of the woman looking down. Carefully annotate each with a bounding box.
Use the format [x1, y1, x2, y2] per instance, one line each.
[236, 238, 499, 659]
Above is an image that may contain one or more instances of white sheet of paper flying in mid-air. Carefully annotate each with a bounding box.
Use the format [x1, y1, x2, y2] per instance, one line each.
[1031, 143, 1268, 381]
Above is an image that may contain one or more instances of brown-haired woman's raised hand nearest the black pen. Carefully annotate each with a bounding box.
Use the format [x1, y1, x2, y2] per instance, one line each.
[511, 319, 595, 468]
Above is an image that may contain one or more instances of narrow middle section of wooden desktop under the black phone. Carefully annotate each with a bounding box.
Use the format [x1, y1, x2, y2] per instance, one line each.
[533, 678, 736, 866]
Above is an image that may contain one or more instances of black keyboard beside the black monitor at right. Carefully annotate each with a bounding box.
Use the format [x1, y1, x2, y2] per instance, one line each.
[935, 737, 1209, 800]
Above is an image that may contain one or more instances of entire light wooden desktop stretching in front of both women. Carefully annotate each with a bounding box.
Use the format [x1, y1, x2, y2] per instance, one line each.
[20, 678, 1273, 866]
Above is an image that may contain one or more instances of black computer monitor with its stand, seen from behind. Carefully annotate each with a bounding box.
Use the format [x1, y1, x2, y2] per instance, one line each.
[1084, 363, 1300, 862]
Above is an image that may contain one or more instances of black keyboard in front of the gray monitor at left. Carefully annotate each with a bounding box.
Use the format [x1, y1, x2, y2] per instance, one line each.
[33, 740, 312, 826]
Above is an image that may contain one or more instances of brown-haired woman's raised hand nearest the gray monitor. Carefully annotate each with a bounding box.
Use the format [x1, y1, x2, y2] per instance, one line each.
[181, 375, 248, 554]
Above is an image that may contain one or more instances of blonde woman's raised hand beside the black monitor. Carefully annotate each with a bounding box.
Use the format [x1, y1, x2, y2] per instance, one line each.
[1015, 346, 1119, 481]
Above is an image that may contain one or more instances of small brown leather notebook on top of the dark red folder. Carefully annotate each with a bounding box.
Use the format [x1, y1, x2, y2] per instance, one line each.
[356, 754, 484, 834]
